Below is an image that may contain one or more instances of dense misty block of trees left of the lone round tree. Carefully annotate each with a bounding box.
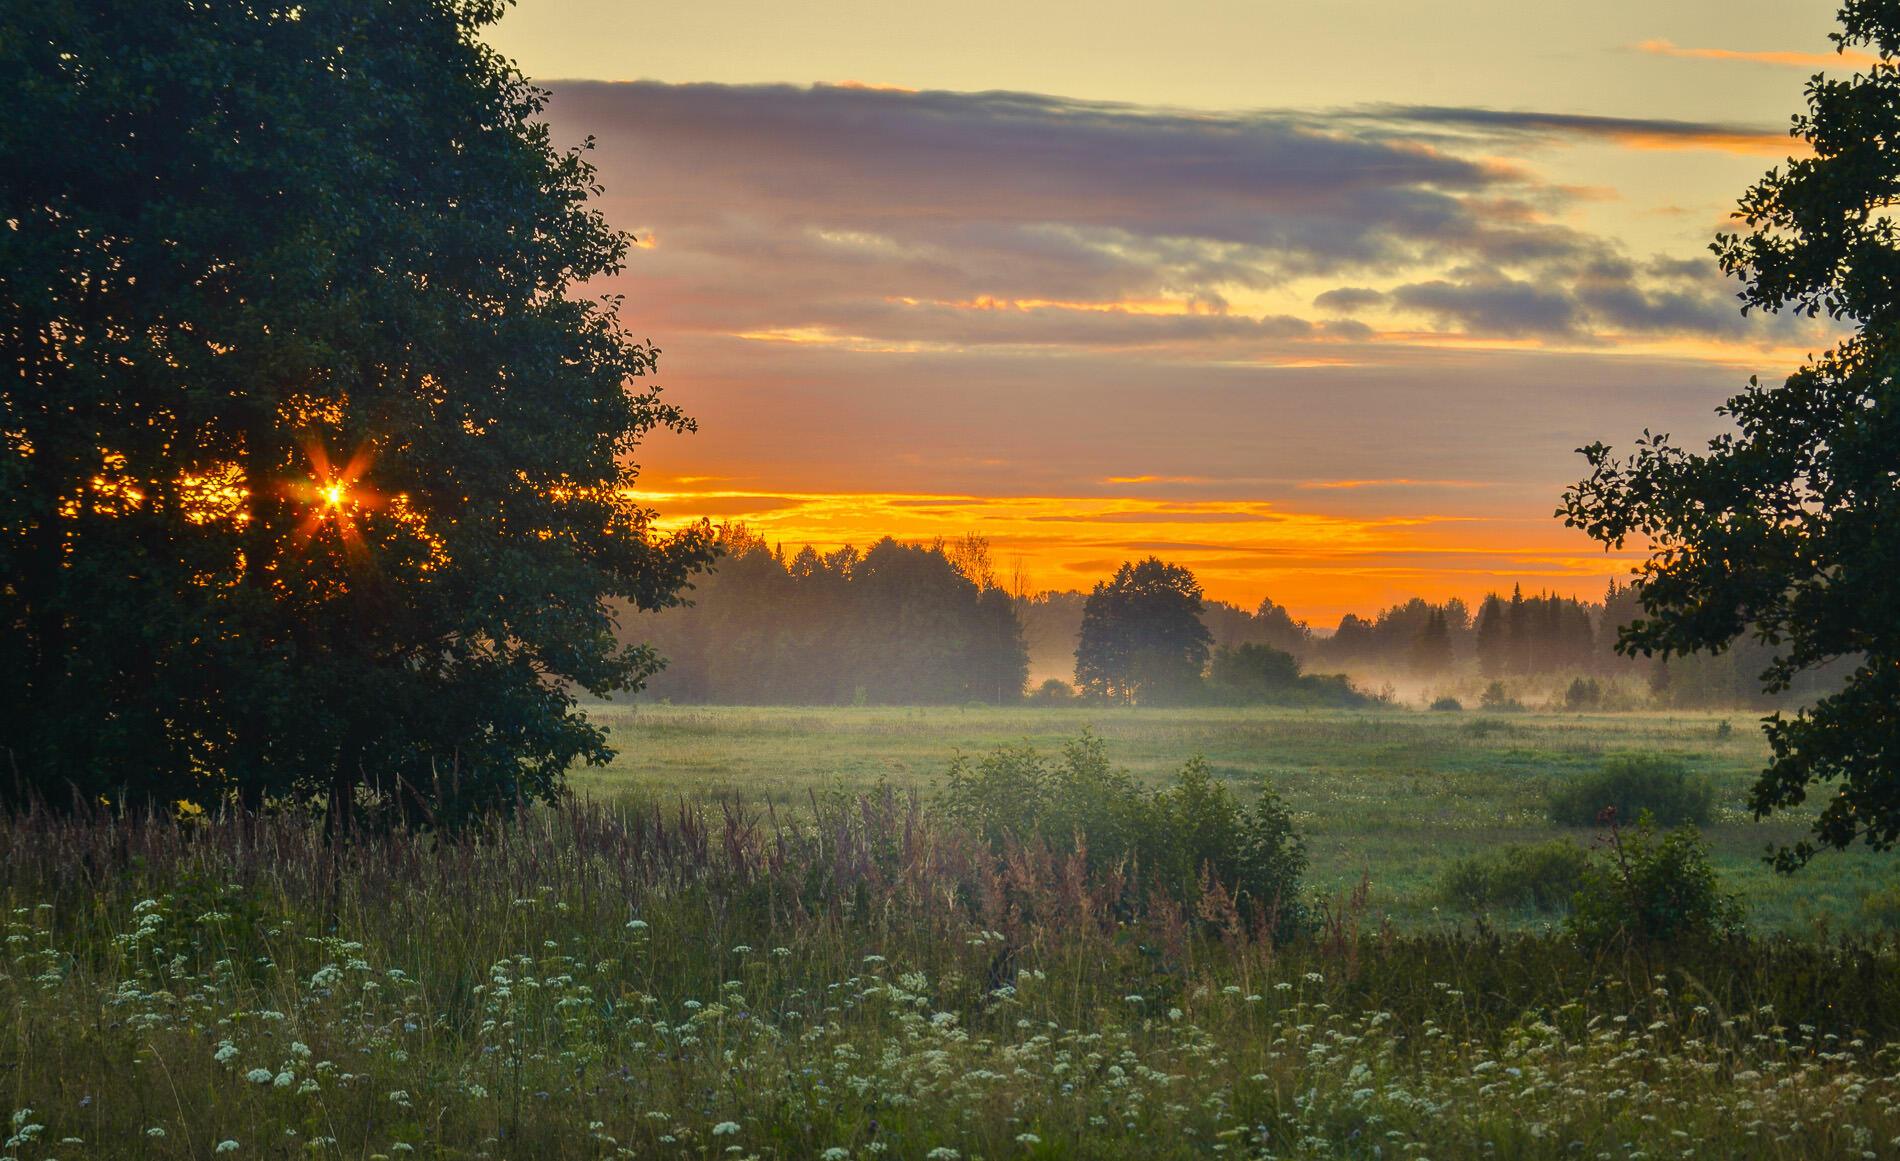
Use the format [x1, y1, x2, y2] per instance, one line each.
[631, 526, 1030, 705]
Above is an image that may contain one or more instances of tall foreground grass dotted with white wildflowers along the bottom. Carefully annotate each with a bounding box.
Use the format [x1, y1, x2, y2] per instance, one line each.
[0, 792, 1900, 1161]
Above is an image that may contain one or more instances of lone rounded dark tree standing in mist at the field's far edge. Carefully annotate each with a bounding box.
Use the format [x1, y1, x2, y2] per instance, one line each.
[1075, 557, 1210, 703]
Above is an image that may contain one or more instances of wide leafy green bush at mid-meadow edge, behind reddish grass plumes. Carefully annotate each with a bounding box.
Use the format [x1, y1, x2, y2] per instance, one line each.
[939, 732, 1309, 939]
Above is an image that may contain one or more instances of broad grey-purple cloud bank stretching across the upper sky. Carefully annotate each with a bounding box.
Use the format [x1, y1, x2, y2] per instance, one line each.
[549, 82, 1808, 349]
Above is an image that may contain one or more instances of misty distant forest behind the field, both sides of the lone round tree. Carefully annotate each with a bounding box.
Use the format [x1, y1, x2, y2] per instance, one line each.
[625, 524, 1839, 709]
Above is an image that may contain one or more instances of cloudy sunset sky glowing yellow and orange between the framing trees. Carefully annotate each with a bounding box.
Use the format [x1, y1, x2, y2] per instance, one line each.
[490, 0, 1858, 625]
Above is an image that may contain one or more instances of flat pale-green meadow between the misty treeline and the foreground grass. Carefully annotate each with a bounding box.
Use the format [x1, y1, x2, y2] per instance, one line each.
[572, 705, 1900, 931]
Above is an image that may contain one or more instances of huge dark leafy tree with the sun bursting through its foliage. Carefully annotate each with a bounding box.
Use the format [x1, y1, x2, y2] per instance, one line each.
[0, 0, 709, 817]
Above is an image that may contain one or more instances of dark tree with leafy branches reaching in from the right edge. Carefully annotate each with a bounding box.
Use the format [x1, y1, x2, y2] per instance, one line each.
[1560, 0, 1900, 868]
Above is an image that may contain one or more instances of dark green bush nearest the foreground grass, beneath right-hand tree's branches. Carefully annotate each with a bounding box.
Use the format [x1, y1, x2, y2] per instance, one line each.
[1568, 813, 1740, 946]
